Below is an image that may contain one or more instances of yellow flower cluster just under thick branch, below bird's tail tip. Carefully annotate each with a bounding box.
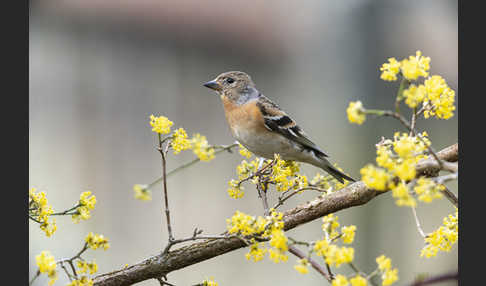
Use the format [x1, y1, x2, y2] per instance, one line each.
[313, 214, 356, 267]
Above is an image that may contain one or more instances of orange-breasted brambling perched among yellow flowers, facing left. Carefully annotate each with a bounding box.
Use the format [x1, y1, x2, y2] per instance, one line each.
[204, 71, 355, 183]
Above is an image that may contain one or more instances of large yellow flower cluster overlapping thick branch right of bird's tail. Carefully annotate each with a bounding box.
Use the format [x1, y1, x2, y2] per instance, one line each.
[360, 132, 436, 207]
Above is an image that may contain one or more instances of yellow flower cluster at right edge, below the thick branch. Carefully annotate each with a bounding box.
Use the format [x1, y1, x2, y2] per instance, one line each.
[420, 210, 459, 258]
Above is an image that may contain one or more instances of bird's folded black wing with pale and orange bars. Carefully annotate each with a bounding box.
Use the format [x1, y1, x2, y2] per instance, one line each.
[257, 94, 328, 157]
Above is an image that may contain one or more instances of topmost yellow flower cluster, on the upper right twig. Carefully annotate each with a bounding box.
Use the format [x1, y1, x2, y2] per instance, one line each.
[380, 51, 430, 81]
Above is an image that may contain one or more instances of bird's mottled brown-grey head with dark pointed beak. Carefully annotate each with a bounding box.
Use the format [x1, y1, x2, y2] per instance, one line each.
[204, 71, 258, 104]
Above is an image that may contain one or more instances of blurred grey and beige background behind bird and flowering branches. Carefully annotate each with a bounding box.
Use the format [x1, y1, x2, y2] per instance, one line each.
[29, 0, 460, 285]
